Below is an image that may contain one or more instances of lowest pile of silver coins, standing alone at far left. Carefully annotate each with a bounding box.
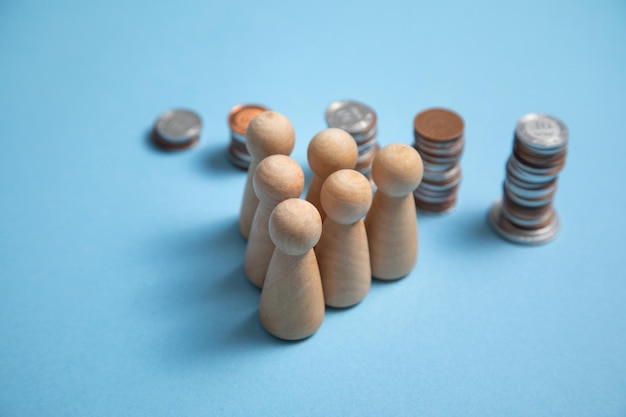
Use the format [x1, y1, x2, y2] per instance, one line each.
[153, 109, 202, 149]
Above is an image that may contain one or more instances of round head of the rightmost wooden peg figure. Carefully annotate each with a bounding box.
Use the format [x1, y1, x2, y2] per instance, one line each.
[372, 143, 424, 197]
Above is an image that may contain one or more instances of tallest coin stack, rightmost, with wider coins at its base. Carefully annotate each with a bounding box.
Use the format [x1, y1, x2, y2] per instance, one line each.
[489, 113, 569, 244]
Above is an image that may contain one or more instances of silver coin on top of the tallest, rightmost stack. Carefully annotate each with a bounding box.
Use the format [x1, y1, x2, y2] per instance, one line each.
[515, 113, 569, 150]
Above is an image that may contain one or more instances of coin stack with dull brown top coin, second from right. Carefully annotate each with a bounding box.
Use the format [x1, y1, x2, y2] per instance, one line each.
[413, 108, 464, 213]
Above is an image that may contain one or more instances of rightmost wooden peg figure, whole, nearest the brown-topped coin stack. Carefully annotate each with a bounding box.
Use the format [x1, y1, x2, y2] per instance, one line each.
[365, 143, 424, 280]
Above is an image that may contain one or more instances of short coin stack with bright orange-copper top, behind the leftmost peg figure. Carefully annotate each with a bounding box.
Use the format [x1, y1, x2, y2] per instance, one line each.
[228, 104, 269, 171]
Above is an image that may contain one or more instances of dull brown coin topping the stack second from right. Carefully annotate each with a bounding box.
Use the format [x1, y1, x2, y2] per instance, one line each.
[413, 108, 464, 142]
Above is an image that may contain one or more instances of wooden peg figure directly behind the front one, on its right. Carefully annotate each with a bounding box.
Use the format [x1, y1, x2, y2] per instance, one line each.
[315, 169, 372, 307]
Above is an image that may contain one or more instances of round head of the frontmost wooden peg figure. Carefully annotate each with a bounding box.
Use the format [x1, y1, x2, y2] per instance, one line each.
[268, 198, 322, 256]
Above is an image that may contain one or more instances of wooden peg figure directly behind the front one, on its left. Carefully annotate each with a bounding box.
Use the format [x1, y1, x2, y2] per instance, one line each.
[244, 155, 304, 288]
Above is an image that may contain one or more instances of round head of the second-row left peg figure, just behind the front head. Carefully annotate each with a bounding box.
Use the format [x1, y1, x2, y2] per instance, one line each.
[252, 155, 304, 209]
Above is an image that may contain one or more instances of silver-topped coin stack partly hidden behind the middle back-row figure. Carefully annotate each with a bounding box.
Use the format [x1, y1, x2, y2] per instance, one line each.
[324, 100, 378, 178]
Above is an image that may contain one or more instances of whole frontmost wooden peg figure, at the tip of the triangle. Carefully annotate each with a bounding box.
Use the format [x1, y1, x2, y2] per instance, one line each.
[259, 198, 325, 340]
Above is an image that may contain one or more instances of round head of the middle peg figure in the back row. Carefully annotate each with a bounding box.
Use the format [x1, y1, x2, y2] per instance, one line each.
[307, 128, 359, 179]
